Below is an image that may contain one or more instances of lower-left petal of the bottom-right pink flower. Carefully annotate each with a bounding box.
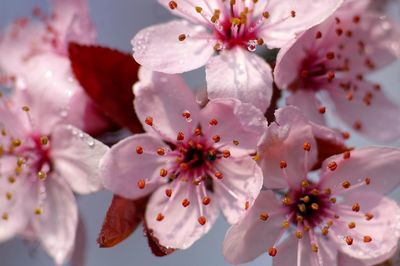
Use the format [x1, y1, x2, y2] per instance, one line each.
[222, 191, 290, 265]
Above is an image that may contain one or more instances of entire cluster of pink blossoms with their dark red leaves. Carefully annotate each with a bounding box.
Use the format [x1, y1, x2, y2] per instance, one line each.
[0, 0, 400, 266]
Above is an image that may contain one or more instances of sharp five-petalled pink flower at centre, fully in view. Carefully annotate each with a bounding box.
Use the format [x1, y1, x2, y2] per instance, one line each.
[101, 68, 266, 249]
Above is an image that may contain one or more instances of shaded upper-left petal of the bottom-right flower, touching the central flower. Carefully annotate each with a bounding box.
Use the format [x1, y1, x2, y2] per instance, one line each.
[258, 107, 317, 188]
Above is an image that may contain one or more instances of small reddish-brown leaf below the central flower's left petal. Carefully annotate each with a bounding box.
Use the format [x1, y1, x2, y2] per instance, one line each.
[97, 195, 148, 248]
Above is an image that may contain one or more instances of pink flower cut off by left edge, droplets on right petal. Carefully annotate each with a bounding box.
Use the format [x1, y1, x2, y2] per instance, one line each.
[0, 85, 108, 265]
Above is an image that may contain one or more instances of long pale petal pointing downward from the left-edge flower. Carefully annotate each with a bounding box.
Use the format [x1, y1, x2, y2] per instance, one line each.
[32, 175, 78, 264]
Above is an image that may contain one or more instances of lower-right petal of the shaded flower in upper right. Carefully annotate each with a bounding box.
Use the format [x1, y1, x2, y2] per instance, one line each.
[330, 81, 400, 141]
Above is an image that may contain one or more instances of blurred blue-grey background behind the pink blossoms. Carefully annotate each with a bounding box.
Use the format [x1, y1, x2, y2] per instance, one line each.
[0, 0, 400, 266]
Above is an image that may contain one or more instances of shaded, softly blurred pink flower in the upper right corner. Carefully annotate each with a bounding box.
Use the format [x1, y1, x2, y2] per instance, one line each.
[275, 7, 400, 141]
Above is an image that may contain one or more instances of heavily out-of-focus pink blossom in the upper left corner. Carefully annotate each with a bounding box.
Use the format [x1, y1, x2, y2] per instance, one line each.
[0, 0, 108, 133]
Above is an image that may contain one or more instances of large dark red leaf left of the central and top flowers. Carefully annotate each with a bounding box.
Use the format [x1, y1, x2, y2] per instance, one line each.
[68, 43, 143, 133]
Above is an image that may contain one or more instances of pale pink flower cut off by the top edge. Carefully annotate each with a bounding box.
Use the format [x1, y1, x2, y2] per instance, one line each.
[132, 0, 342, 111]
